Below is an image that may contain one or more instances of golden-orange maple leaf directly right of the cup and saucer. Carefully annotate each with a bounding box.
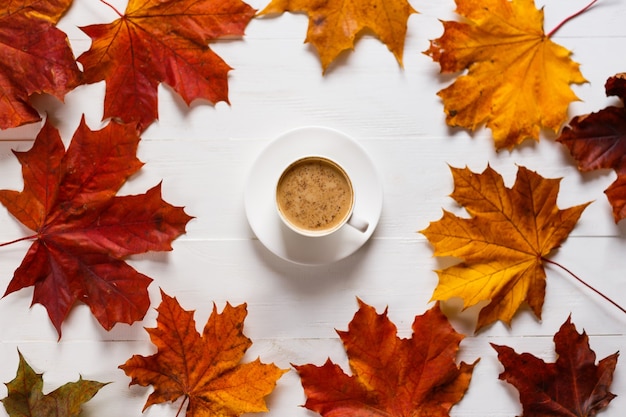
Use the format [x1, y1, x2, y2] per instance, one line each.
[421, 166, 589, 330]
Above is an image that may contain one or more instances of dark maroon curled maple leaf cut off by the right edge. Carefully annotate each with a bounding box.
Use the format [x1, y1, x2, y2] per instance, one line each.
[557, 73, 626, 223]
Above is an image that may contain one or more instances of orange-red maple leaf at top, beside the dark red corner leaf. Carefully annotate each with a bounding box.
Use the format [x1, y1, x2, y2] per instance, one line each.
[78, 0, 255, 130]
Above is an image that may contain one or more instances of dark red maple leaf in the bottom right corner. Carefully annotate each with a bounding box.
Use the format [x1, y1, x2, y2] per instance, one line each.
[492, 318, 618, 417]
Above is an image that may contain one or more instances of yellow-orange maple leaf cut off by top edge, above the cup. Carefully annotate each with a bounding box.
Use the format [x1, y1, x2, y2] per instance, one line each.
[259, 0, 416, 71]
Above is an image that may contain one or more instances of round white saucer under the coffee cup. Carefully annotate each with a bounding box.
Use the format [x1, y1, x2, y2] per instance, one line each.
[244, 127, 383, 265]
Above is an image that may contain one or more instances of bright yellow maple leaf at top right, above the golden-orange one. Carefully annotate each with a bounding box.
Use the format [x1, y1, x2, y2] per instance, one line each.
[424, 0, 587, 150]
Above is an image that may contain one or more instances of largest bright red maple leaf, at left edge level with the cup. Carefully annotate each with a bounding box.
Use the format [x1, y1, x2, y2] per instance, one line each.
[0, 118, 191, 336]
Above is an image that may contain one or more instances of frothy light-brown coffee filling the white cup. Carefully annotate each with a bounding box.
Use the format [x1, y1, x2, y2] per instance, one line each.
[276, 157, 354, 232]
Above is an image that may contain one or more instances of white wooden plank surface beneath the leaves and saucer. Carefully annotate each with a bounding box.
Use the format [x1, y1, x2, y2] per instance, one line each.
[0, 0, 626, 417]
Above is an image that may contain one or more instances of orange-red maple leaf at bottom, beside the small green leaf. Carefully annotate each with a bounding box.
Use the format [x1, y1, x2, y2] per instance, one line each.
[120, 291, 286, 417]
